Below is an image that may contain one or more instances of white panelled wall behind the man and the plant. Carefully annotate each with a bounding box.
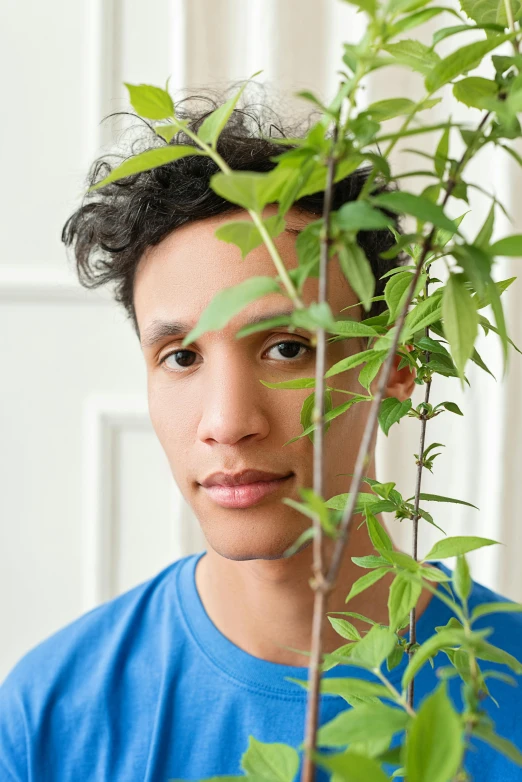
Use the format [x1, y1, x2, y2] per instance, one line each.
[0, 0, 522, 677]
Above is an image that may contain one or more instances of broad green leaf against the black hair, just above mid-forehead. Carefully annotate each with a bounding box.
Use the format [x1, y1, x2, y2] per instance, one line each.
[210, 168, 286, 212]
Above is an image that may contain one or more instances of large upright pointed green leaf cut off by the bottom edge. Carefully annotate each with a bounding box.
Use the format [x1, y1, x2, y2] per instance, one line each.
[405, 682, 465, 782]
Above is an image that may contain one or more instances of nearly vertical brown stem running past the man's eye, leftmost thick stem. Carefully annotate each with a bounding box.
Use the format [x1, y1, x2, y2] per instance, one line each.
[301, 124, 338, 782]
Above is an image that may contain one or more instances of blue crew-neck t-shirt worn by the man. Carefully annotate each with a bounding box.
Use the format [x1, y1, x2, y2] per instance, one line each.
[0, 552, 522, 782]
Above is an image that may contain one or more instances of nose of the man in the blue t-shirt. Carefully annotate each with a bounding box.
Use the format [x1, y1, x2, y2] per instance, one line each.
[194, 350, 268, 445]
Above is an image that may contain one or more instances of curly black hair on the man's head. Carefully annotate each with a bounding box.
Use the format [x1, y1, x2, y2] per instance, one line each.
[61, 84, 403, 338]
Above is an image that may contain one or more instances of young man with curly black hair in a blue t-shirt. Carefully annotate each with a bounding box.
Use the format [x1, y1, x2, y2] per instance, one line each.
[0, 101, 522, 782]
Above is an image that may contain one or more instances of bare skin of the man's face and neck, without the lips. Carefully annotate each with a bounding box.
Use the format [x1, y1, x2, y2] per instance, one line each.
[134, 205, 432, 667]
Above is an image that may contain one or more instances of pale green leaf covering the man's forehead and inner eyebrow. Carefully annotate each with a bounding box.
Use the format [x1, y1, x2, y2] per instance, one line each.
[181, 277, 280, 347]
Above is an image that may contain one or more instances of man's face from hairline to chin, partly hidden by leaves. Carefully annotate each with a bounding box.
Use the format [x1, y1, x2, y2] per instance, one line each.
[134, 206, 369, 560]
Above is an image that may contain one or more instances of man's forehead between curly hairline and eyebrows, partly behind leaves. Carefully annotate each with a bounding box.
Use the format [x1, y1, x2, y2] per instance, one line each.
[134, 205, 357, 333]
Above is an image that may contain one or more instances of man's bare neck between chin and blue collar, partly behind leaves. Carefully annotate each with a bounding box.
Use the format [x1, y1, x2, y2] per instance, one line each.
[196, 516, 432, 667]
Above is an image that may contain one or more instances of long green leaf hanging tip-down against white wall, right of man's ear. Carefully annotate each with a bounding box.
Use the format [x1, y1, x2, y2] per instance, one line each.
[442, 274, 478, 380]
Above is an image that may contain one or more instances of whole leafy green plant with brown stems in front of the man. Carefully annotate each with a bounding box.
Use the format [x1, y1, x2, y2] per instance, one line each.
[85, 0, 522, 782]
